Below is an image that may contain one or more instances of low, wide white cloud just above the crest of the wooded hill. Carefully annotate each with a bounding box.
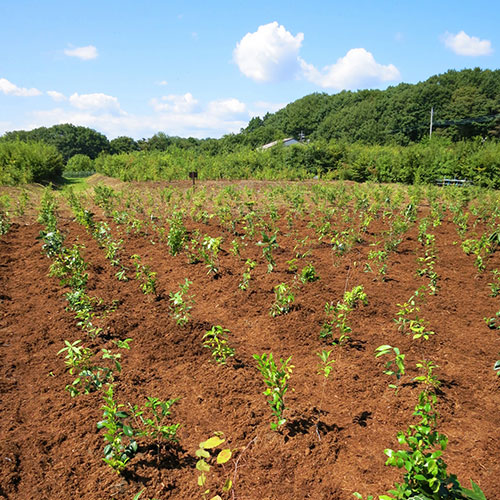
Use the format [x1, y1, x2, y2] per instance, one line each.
[300, 48, 400, 90]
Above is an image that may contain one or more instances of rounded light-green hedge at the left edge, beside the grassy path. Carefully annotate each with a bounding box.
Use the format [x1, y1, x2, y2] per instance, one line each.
[0, 141, 64, 186]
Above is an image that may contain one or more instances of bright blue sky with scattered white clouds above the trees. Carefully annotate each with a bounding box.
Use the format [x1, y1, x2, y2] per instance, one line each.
[0, 0, 500, 139]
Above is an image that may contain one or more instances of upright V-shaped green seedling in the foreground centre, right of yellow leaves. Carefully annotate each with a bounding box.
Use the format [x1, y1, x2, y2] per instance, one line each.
[253, 352, 293, 431]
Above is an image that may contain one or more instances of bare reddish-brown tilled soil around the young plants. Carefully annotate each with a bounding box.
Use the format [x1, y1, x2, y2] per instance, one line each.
[0, 181, 500, 500]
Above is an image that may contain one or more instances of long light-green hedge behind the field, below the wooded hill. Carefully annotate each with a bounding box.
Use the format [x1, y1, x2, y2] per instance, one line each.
[94, 138, 500, 189]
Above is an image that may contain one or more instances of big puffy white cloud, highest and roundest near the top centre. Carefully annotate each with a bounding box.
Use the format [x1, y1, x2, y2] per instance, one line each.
[233, 21, 304, 82]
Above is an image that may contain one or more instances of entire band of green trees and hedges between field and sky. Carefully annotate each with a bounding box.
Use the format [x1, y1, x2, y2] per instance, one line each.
[0, 68, 500, 188]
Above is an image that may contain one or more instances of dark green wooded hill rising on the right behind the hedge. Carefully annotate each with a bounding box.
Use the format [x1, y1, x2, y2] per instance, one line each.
[239, 68, 500, 145]
